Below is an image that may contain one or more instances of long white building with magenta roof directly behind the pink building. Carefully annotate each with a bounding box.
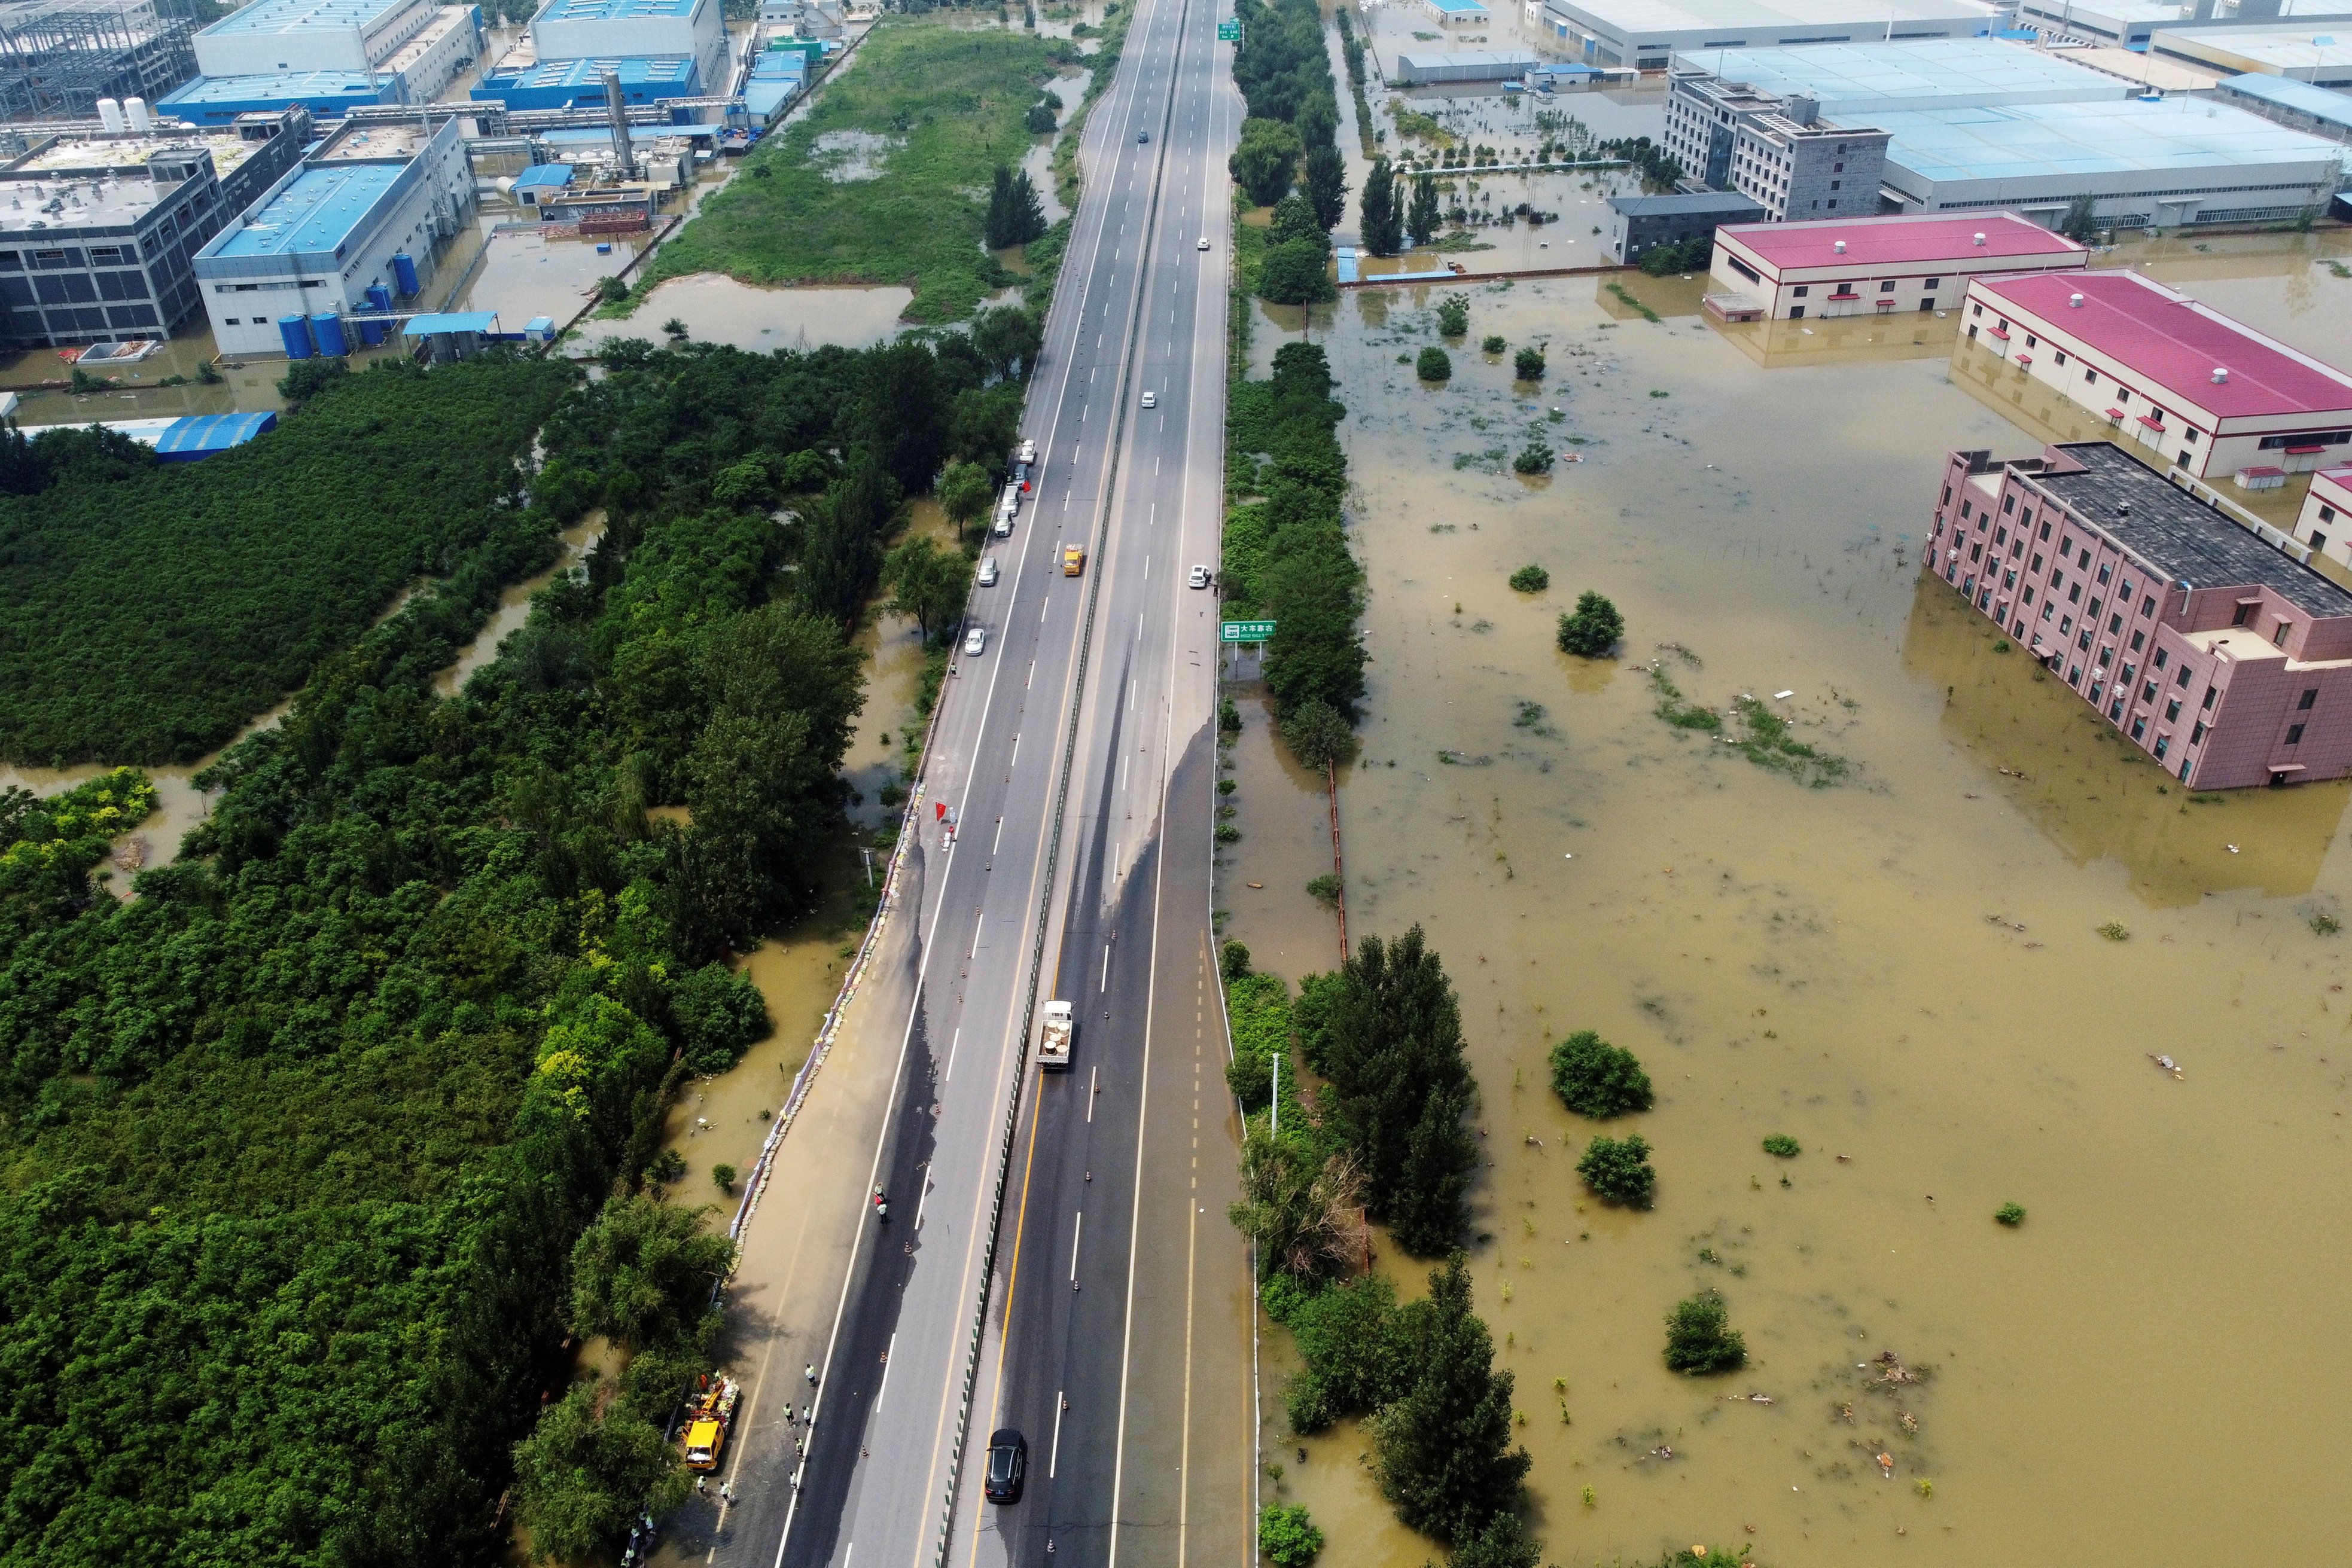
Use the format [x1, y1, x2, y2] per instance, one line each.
[1961, 270, 2352, 489]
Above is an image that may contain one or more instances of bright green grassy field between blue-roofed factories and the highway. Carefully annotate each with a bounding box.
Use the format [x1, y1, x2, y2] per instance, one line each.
[638, 17, 1068, 322]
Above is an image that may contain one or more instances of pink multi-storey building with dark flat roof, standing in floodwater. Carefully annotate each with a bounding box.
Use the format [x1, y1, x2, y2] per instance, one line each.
[1921, 442, 2352, 790]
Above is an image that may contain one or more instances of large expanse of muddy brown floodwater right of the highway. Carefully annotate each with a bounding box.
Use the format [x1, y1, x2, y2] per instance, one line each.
[1218, 242, 2352, 1568]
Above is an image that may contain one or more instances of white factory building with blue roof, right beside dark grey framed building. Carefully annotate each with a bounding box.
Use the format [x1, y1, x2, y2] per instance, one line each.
[195, 111, 473, 358]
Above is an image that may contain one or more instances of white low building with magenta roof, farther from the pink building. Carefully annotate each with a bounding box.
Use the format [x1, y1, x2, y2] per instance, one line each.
[1710, 212, 2091, 322]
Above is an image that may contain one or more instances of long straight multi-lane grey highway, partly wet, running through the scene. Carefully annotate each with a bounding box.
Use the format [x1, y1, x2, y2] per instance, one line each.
[696, 0, 1256, 1568]
